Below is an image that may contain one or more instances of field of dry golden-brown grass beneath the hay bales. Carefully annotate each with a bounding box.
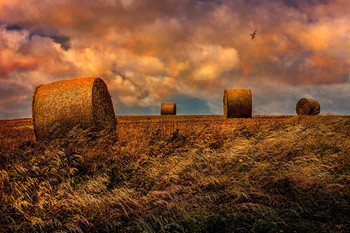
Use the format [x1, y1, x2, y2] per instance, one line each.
[0, 115, 350, 232]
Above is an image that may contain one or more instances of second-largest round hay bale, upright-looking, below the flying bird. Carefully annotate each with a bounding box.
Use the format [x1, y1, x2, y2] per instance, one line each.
[223, 89, 252, 118]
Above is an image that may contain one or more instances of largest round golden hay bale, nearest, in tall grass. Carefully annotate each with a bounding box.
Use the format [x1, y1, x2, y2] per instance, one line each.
[32, 78, 116, 140]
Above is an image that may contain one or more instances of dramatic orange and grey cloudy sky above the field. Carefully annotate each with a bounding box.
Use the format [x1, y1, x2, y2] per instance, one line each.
[0, 0, 350, 119]
